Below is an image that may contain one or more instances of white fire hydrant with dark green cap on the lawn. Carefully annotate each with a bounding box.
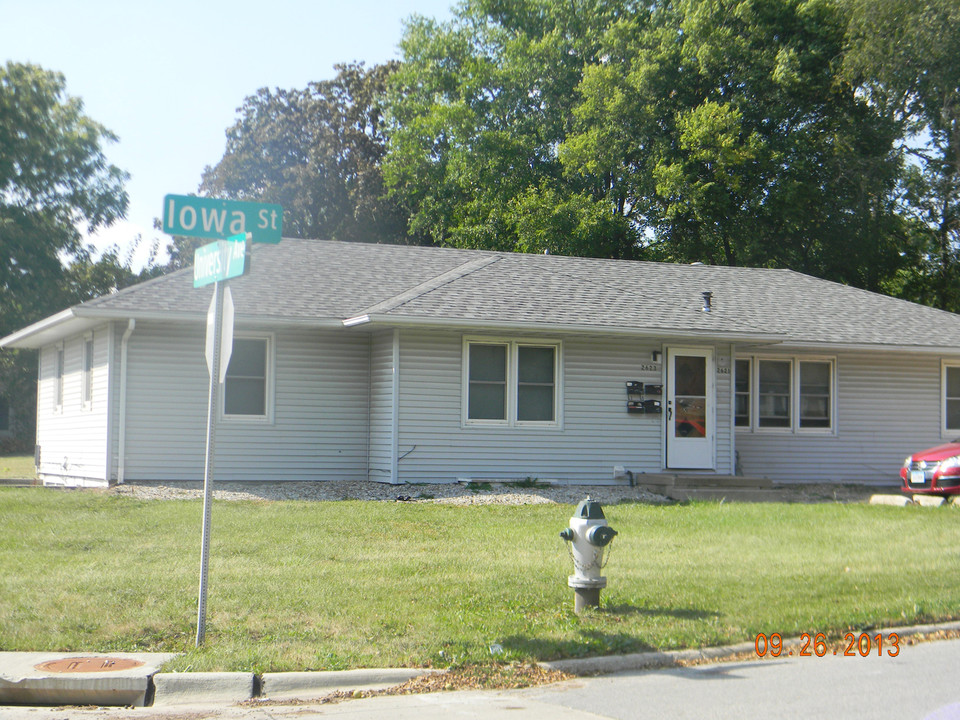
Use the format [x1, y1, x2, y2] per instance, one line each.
[560, 497, 617, 613]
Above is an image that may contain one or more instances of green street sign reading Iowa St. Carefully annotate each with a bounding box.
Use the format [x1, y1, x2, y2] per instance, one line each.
[163, 195, 283, 243]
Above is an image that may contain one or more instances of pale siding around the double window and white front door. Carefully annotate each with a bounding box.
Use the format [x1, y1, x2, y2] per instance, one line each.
[390, 330, 733, 482]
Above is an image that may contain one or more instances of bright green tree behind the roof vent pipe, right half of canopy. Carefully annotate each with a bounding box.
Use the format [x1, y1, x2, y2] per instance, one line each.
[561, 0, 902, 289]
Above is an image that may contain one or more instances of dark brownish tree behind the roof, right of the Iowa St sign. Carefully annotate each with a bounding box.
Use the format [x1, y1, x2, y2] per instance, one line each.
[195, 63, 405, 256]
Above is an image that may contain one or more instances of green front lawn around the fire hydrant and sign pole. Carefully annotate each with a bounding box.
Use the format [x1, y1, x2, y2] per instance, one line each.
[0, 488, 960, 672]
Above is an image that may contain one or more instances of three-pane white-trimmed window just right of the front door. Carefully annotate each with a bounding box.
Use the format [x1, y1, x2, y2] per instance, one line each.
[734, 357, 832, 432]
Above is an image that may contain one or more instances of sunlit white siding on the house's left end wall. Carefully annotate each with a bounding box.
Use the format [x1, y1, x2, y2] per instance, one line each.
[37, 326, 111, 485]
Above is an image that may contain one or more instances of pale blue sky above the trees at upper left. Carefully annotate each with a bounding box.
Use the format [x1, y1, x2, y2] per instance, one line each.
[0, 0, 454, 267]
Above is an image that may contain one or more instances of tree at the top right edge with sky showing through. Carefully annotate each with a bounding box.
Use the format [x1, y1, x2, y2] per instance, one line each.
[844, 0, 960, 311]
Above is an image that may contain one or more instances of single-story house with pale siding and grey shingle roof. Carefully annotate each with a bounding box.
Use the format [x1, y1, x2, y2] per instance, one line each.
[0, 239, 960, 485]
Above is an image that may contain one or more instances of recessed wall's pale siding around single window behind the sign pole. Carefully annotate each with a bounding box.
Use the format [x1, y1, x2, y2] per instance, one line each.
[125, 322, 370, 482]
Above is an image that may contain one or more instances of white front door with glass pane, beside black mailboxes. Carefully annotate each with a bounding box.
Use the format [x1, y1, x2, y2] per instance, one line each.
[664, 347, 716, 470]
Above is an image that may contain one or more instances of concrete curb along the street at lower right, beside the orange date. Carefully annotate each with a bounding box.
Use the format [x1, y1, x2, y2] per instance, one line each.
[537, 621, 960, 675]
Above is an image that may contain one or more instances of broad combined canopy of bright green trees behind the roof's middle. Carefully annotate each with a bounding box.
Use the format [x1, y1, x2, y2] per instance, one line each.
[385, 0, 916, 289]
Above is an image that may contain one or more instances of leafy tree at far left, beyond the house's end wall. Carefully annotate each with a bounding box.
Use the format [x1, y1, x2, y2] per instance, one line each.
[0, 62, 127, 446]
